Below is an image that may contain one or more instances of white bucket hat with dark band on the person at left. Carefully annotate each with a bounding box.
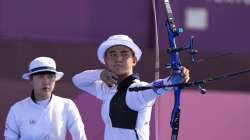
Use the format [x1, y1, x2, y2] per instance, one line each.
[23, 56, 64, 81]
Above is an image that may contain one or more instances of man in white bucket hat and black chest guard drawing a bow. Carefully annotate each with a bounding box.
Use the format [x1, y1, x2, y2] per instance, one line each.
[73, 35, 189, 140]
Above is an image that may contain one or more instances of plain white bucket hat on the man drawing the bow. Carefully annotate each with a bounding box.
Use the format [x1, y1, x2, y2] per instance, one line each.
[97, 35, 142, 64]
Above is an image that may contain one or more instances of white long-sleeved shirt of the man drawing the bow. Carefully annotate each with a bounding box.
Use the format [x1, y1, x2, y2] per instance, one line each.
[72, 70, 170, 140]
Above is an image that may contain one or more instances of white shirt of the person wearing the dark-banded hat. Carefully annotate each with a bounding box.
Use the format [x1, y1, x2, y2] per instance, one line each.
[4, 95, 86, 140]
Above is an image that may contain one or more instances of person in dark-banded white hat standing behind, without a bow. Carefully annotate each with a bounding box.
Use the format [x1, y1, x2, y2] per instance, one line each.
[4, 57, 87, 140]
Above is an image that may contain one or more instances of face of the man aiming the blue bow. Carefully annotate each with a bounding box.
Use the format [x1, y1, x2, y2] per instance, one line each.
[104, 45, 137, 77]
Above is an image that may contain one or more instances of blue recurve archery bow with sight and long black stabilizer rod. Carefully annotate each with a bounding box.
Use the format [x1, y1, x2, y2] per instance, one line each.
[129, 0, 250, 140]
